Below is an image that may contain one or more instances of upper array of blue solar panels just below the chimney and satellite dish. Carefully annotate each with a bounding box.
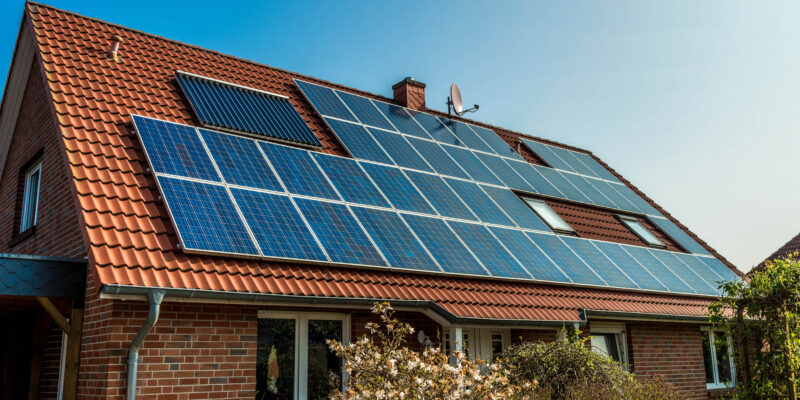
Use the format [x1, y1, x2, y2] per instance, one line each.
[296, 80, 709, 255]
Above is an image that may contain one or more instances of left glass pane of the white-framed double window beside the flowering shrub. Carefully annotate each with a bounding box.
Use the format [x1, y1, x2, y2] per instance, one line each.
[256, 318, 295, 400]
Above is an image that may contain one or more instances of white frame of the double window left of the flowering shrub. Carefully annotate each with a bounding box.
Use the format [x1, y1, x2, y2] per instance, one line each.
[258, 310, 350, 400]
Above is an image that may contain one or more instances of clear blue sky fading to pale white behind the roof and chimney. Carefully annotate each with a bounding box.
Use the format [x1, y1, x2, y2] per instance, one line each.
[0, 0, 800, 271]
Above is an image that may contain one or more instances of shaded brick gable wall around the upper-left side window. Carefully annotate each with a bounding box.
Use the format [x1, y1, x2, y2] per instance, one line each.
[0, 64, 86, 258]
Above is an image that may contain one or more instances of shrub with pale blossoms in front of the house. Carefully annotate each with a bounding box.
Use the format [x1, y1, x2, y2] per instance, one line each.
[328, 303, 537, 400]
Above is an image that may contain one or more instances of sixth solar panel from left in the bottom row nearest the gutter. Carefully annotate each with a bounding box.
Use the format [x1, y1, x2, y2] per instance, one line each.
[448, 221, 531, 279]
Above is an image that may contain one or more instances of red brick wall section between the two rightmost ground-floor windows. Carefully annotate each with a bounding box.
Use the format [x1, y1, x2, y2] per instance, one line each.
[627, 323, 708, 399]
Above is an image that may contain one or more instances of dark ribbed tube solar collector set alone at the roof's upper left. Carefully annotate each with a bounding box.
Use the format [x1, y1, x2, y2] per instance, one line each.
[176, 72, 322, 147]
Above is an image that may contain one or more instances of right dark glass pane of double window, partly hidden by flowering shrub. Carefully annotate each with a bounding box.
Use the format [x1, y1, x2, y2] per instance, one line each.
[308, 320, 342, 400]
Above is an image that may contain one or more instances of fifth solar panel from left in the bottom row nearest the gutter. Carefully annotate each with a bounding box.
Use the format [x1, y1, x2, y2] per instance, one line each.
[403, 214, 487, 276]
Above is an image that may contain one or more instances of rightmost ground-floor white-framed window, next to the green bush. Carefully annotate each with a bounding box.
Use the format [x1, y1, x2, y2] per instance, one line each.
[701, 328, 736, 389]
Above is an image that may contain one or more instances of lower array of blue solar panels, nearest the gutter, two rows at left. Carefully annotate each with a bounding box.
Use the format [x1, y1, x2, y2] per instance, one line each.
[133, 114, 733, 295]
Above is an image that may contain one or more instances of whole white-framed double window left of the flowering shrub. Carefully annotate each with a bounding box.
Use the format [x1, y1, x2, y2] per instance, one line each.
[256, 311, 349, 400]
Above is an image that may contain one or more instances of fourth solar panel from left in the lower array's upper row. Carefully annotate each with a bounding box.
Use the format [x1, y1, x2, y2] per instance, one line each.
[313, 153, 391, 207]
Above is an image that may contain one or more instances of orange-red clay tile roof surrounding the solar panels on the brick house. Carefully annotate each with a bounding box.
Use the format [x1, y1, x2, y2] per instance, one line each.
[15, 3, 738, 321]
